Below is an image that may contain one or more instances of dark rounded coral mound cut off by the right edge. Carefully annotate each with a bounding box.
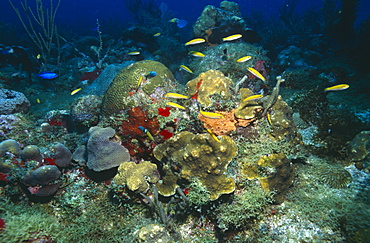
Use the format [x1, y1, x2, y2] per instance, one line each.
[349, 131, 370, 161]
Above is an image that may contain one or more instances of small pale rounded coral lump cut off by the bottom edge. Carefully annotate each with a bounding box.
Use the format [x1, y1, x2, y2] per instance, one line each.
[136, 224, 175, 243]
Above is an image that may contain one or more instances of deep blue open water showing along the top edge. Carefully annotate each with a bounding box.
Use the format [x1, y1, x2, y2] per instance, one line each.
[0, 0, 370, 37]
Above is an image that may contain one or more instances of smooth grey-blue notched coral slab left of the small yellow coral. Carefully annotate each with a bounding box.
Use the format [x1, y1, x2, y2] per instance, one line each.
[87, 127, 130, 172]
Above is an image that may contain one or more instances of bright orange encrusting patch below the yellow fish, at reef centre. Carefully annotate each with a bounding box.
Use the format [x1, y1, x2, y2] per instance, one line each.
[198, 110, 255, 136]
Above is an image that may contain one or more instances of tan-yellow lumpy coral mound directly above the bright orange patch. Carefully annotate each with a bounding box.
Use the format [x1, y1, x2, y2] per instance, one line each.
[186, 70, 233, 107]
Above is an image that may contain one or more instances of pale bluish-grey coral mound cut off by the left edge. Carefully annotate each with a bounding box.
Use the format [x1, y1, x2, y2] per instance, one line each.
[0, 88, 31, 115]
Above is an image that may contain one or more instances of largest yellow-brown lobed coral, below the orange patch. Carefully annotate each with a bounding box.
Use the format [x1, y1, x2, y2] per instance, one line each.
[153, 132, 237, 200]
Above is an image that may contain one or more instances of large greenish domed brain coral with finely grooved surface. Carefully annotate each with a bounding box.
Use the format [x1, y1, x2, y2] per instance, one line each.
[101, 60, 175, 115]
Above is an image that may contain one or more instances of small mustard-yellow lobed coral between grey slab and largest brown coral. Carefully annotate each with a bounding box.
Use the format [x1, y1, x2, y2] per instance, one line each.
[113, 161, 158, 193]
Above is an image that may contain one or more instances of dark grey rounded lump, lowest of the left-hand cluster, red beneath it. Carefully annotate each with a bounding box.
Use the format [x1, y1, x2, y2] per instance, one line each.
[23, 165, 61, 186]
